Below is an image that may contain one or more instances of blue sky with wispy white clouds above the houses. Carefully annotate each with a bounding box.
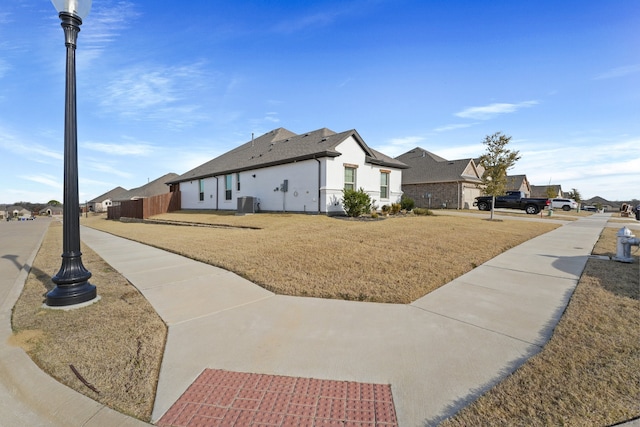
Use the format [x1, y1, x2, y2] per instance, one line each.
[0, 0, 640, 203]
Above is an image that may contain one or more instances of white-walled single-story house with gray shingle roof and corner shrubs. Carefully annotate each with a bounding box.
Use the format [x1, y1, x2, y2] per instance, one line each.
[169, 128, 407, 215]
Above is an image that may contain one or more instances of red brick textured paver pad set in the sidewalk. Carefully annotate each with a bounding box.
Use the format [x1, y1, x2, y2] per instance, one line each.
[157, 369, 398, 427]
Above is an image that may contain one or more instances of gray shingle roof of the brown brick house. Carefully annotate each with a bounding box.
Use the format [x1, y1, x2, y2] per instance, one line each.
[396, 147, 480, 184]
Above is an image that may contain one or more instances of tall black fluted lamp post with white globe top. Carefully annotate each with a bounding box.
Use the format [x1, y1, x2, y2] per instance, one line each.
[46, 0, 97, 307]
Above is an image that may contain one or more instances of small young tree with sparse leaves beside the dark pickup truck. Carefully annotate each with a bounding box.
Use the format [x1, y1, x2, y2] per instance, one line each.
[480, 132, 520, 219]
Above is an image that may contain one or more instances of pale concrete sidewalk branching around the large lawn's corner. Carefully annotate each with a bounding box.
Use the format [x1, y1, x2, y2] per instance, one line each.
[76, 214, 609, 427]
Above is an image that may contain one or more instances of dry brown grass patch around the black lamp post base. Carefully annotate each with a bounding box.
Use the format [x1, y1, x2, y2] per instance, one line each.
[11, 222, 166, 424]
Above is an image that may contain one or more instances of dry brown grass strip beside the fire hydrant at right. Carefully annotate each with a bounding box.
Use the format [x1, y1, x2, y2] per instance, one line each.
[442, 228, 640, 427]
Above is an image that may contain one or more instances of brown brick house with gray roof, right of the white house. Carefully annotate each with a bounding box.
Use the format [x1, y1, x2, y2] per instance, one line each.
[396, 147, 482, 209]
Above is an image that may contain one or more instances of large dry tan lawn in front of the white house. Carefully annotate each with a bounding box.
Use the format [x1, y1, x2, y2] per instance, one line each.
[85, 212, 558, 304]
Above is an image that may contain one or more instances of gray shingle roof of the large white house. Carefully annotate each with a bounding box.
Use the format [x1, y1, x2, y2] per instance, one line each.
[167, 128, 406, 184]
